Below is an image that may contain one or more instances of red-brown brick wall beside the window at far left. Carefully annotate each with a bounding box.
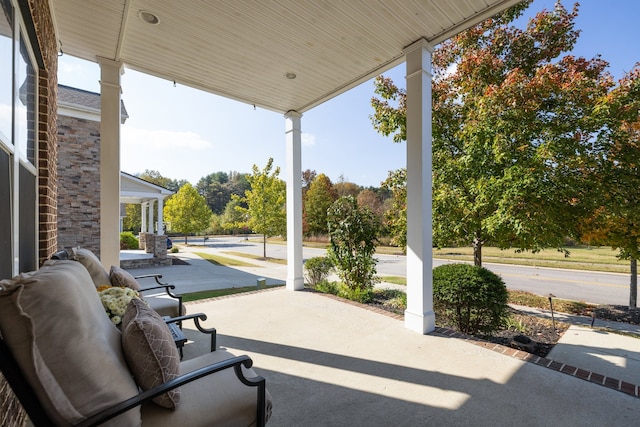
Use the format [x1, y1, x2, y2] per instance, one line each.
[0, 4, 58, 426]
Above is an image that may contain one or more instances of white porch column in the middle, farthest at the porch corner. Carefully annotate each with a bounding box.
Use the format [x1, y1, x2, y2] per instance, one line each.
[284, 111, 304, 291]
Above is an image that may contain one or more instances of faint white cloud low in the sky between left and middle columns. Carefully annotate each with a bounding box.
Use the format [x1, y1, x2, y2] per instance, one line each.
[122, 126, 212, 151]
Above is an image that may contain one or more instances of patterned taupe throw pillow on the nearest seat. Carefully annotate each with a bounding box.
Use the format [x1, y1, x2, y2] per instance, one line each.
[122, 298, 180, 409]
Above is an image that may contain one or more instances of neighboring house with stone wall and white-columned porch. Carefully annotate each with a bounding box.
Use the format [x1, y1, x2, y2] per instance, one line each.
[57, 85, 173, 267]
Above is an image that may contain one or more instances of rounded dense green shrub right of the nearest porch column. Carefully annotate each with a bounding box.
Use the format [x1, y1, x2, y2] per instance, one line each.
[433, 264, 509, 335]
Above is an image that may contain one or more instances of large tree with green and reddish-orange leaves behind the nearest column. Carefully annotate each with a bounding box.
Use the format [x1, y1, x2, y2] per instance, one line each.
[372, 2, 611, 265]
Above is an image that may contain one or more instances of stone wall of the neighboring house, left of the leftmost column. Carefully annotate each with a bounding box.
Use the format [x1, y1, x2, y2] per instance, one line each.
[58, 116, 100, 257]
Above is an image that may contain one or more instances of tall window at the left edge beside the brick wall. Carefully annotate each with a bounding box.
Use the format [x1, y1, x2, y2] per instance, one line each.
[0, 0, 38, 279]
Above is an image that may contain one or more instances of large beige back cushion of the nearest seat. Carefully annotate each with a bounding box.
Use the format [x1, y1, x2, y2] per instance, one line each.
[0, 261, 141, 426]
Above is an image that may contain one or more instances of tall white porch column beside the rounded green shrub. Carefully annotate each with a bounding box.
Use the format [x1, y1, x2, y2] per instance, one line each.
[404, 40, 435, 334]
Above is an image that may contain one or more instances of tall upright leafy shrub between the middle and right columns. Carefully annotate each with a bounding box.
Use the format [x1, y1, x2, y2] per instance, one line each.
[327, 196, 380, 294]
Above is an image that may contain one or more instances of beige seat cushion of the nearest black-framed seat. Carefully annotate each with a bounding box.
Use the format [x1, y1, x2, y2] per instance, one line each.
[142, 349, 272, 427]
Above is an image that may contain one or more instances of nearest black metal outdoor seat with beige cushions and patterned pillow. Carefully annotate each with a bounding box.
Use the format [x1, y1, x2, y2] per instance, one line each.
[0, 260, 272, 427]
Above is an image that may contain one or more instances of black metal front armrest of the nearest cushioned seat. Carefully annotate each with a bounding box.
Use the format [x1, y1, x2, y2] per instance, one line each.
[76, 355, 266, 427]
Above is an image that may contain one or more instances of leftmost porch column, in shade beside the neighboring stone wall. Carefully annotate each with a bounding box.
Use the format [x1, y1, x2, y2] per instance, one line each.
[98, 58, 123, 269]
